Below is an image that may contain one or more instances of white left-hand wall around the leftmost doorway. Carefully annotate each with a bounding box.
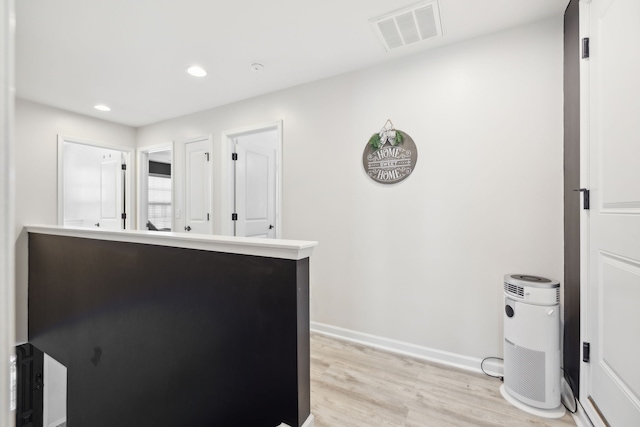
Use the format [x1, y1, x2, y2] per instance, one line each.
[15, 99, 136, 342]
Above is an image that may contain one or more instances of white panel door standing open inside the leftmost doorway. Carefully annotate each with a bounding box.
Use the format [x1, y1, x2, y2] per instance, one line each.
[96, 153, 124, 230]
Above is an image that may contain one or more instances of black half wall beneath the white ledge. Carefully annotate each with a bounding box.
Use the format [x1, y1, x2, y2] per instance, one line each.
[29, 233, 310, 427]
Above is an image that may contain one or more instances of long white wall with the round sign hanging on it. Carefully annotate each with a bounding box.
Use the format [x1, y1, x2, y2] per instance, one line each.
[137, 17, 563, 358]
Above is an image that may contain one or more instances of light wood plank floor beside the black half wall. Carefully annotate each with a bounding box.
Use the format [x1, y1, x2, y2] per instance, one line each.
[311, 333, 576, 427]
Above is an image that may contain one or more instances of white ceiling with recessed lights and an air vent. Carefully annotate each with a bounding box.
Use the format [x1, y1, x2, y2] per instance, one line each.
[15, 0, 568, 127]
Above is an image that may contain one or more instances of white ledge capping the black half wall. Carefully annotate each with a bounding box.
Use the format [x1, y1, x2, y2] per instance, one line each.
[25, 225, 318, 260]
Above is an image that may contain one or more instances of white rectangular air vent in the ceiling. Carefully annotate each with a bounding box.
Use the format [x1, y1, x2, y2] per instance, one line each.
[371, 1, 442, 52]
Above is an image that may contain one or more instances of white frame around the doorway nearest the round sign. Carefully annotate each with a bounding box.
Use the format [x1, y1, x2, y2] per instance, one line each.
[220, 120, 283, 239]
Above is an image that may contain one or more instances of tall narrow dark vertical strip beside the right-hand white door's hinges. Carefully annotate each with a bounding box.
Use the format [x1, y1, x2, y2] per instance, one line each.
[563, 0, 581, 395]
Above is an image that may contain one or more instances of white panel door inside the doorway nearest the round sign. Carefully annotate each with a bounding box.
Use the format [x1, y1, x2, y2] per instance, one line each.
[235, 139, 276, 238]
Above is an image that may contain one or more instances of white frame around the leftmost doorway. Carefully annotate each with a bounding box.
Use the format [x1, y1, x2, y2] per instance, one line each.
[58, 134, 136, 230]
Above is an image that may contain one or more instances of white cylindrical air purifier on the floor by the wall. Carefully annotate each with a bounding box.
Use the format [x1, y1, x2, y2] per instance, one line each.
[500, 274, 565, 418]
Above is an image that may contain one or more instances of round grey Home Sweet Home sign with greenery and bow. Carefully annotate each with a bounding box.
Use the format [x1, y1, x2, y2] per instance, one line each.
[362, 120, 418, 184]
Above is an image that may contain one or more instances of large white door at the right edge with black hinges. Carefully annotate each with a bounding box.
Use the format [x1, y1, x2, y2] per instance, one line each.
[583, 0, 640, 427]
